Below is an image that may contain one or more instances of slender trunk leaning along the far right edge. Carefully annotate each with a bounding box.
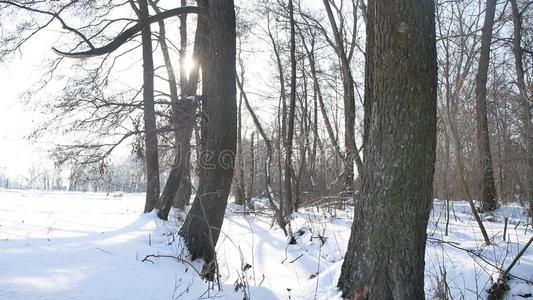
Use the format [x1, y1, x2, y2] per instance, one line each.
[511, 0, 533, 217]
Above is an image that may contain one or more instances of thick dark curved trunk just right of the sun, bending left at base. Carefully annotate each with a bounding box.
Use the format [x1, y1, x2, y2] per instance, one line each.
[180, 0, 237, 277]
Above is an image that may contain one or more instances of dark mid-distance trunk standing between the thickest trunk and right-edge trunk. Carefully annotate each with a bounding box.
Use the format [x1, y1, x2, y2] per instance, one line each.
[476, 0, 498, 211]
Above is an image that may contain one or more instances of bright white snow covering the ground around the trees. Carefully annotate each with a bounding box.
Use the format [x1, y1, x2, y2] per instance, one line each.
[0, 190, 533, 300]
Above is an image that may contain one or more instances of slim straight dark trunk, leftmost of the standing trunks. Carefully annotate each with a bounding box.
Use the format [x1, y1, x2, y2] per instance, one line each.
[139, 0, 159, 213]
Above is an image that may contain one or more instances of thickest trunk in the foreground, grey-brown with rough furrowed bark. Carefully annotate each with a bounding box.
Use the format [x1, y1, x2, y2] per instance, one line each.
[338, 0, 437, 299]
